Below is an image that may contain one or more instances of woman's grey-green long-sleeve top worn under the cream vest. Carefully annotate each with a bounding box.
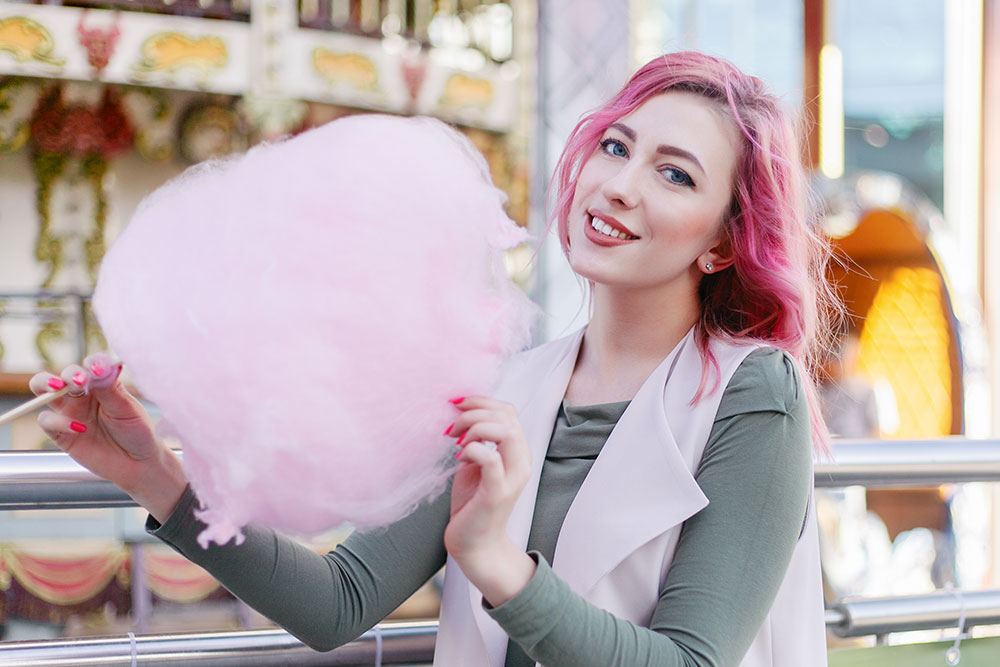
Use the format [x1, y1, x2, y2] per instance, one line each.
[148, 348, 812, 667]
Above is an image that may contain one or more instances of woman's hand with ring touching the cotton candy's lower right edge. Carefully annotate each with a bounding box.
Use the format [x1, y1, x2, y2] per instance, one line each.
[444, 396, 535, 606]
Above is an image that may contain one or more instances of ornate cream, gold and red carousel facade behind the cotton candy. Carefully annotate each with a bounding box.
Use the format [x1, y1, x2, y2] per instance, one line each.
[0, 0, 530, 639]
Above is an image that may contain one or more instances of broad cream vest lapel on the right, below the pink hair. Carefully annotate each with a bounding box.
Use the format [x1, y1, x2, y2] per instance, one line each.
[553, 332, 711, 596]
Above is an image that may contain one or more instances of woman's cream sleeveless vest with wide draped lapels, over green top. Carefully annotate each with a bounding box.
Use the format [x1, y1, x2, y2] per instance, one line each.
[434, 330, 826, 667]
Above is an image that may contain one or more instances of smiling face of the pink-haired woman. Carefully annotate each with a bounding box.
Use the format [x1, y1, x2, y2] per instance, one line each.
[567, 91, 738, 294]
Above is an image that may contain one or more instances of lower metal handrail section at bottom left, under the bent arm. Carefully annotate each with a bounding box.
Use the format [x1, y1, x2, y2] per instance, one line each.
[0, 621, 437, 667]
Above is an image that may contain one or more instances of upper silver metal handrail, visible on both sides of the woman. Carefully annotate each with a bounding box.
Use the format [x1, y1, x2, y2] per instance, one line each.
[0, 438, 1000, 510]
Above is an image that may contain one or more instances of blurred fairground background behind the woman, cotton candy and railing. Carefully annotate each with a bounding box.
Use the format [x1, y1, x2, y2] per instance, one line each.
[0, 0, 1000, 664]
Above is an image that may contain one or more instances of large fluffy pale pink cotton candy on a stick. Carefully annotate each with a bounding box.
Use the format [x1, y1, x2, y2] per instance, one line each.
[94, 115, 534, 546]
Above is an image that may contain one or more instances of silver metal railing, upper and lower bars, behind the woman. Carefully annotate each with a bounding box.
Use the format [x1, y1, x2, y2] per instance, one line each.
[0, 438, 1000, 667]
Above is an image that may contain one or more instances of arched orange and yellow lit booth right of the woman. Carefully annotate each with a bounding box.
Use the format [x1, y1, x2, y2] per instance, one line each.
[819, 172, 982, 587]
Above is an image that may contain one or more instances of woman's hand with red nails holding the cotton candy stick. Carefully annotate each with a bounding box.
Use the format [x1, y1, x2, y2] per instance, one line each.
[29, 354, 187, 522]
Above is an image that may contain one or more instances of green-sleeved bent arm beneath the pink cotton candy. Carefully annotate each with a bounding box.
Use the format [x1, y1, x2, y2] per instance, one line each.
[154, 486, 447, 650]
